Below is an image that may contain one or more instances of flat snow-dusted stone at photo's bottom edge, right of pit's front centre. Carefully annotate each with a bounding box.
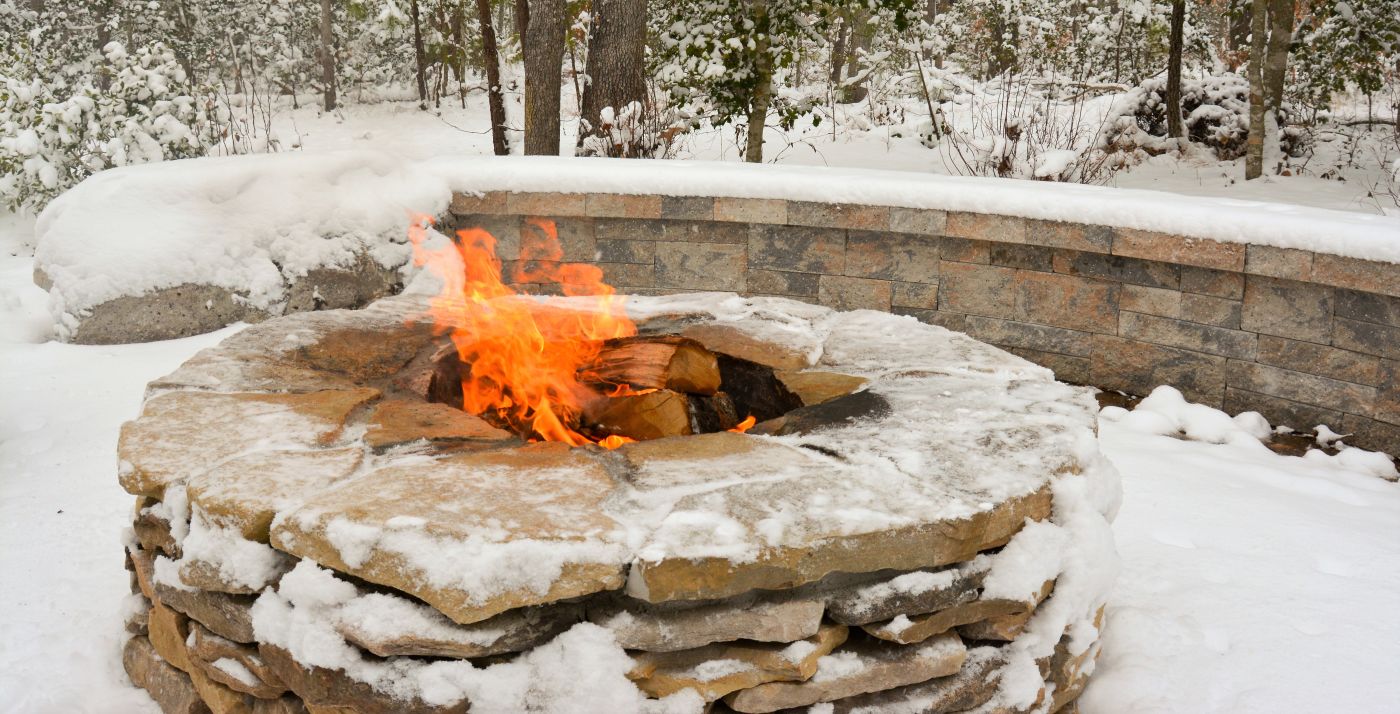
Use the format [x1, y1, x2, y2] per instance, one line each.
[724, 633, 967, 714]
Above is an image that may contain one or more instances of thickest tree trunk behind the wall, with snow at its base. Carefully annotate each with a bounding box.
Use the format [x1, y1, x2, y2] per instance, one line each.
[578, 0, 647, 157]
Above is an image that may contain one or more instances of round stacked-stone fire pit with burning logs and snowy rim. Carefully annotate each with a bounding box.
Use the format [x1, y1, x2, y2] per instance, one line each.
[120, 224, 1116, 713]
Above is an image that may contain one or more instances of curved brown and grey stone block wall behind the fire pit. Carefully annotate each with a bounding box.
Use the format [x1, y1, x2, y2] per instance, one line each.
[451, 192, 1400, 454]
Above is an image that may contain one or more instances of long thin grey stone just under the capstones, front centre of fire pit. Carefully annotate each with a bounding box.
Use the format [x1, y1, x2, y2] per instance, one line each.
[588, 599, 823, 652]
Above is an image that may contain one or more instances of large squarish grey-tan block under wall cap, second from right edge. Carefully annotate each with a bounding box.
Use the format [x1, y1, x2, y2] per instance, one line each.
[1240, 276, 1334, 344]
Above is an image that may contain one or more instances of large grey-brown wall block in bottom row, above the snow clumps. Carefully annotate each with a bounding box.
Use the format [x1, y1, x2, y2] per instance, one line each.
[1089, 335, 1226, 409]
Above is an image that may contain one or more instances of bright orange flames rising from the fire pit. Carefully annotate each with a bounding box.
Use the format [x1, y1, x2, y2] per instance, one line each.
[409, 216, 637, 448]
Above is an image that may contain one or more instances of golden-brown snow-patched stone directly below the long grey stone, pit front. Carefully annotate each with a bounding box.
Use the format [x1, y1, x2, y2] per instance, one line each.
[627, 624, 847, 701]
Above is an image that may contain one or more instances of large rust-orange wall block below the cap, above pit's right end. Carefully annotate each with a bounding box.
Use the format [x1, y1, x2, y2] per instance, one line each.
[1015, 270, 1119, 335]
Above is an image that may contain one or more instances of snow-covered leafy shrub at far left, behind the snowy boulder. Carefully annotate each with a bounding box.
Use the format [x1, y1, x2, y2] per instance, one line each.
[0, 42, 224, 211]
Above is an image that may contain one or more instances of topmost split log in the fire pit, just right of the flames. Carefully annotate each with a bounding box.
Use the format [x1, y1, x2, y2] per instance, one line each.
[580, 335, 720, 395]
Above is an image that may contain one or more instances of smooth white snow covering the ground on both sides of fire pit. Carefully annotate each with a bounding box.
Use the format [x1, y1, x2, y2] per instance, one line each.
[0, 215, 1400, 714]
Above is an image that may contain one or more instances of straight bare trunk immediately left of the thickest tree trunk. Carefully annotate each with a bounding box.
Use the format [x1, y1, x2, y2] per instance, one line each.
[525, 0, 566, 155]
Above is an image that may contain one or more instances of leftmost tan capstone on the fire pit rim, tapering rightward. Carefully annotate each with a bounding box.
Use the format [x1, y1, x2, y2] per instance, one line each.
[118, 389, 379, 497]
